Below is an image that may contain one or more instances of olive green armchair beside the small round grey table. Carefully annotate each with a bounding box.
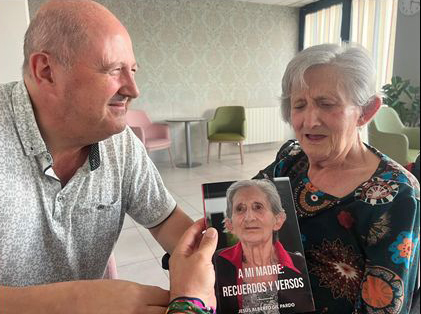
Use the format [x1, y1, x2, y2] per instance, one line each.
[207, 106, 246, 164]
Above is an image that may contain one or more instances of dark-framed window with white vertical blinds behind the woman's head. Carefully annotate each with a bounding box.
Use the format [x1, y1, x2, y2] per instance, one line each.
[299, 0, 398, 89]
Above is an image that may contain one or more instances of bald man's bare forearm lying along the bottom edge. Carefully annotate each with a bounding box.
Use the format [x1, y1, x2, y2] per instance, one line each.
[0, 280, 169, 314]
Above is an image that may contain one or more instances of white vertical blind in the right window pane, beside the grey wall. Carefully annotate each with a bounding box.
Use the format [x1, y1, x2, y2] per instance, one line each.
[350, 0, 398, 90]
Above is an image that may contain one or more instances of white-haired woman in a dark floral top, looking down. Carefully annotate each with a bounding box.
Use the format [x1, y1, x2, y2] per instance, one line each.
[257, 45, 420, 313]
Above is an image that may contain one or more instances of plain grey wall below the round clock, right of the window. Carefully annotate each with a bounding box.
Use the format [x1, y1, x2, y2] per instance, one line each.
[393, 0, 420, 86]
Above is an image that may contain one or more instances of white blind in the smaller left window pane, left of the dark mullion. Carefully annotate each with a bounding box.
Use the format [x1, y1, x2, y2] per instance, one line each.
[304, 4, 342, 49]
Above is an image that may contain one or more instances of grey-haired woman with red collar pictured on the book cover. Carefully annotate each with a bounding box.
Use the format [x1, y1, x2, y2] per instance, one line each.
[215, 180, 313, 314]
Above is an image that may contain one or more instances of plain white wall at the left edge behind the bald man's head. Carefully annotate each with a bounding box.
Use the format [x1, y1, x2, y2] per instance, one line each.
[0, 0, 29, 83]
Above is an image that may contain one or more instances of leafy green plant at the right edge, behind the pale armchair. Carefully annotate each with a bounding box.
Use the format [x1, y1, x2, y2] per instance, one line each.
[382, 76, 420, 127]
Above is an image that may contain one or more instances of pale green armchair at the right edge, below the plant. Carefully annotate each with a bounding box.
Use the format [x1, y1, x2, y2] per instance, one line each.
[368, 106, 420, 166]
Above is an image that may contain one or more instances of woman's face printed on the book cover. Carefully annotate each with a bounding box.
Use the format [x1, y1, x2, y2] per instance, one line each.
[227, 186, 285, 244]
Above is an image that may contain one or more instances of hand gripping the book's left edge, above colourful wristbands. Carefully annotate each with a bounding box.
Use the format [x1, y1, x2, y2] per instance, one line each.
[170, 218, 218, 306]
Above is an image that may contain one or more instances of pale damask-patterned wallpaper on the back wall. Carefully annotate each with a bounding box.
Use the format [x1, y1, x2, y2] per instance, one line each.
[28, 0, 298, 160]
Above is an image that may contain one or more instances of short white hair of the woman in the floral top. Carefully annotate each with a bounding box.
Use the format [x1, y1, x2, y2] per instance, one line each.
[281, 43, 377, 123]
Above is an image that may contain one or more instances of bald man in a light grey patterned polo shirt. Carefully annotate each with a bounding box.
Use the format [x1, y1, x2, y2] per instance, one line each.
[0, 1, 192, 314]
